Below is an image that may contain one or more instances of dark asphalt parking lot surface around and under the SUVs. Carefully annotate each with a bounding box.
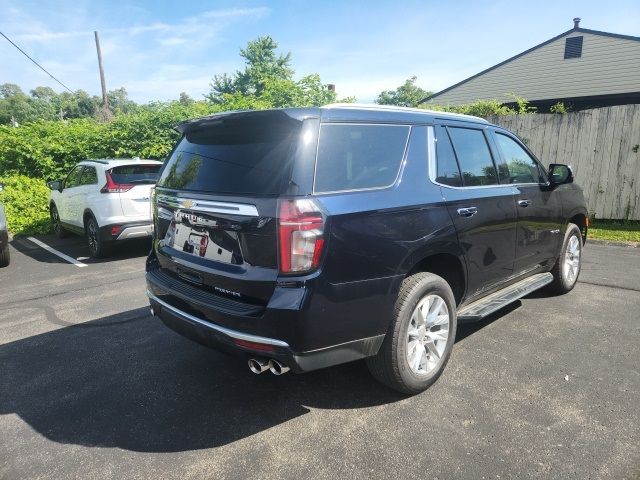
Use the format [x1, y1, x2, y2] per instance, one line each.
[0, 237, 640, 480]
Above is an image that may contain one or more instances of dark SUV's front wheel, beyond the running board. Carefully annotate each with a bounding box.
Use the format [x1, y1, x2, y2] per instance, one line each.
[547, 223, 583, 295]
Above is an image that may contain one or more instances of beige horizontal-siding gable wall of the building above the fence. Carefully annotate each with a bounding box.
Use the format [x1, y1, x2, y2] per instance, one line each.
[427, 32, 640, 105]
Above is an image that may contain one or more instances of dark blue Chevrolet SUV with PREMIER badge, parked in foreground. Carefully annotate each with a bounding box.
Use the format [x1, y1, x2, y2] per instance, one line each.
[146, 105, 588, 393]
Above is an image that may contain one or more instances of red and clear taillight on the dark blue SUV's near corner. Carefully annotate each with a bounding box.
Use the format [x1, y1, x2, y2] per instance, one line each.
[278, 199, 324, 273]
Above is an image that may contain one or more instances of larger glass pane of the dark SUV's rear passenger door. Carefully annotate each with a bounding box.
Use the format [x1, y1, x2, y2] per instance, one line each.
[447, 127, 498, 187]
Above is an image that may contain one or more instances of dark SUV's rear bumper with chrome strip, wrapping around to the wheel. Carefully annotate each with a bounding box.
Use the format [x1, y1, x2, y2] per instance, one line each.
[146, 262, 399, 372]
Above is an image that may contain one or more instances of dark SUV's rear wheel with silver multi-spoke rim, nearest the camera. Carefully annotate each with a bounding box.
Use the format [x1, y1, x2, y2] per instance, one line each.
[367, 272, 457, 394]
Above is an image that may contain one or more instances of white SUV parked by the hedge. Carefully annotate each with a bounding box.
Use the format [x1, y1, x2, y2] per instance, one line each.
[49, 158, 162, 257]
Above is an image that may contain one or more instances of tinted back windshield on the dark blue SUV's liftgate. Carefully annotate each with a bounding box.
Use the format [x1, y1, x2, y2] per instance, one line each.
[158, 112, 302, 195]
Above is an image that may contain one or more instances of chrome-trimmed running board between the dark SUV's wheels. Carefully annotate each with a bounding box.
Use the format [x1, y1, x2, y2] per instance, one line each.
[458, 272, 553, 322]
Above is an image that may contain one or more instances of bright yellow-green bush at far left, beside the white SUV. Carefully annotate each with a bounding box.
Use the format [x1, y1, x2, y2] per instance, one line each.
[0, 175, 51, 235]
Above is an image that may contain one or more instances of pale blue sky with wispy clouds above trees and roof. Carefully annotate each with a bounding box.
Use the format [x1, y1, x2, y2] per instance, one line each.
[0, 0, 640, 102]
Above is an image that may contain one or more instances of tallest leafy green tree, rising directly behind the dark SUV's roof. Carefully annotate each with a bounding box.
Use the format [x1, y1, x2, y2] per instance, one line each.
[205, 36, 336, 110]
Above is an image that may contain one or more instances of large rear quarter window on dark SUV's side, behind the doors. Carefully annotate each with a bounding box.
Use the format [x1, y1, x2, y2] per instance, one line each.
[314, 124, 409, 193]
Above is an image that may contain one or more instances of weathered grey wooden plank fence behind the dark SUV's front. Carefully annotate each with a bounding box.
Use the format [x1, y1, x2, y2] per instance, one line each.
[487, 105, 640, 220]
